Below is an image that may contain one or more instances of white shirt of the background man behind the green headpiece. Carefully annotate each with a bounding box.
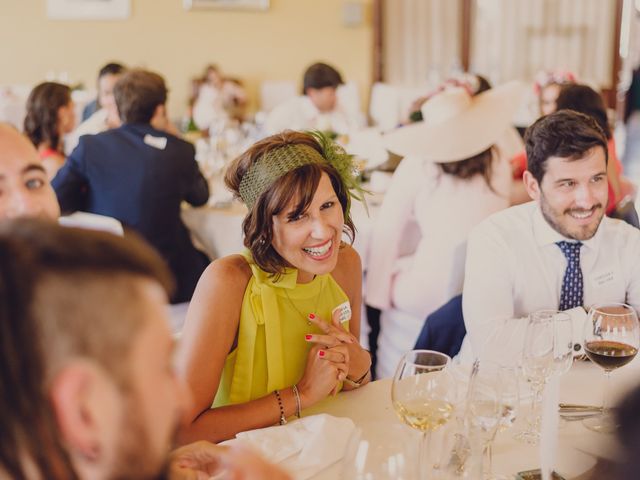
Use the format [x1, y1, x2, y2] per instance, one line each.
[265, 95, 360, 135]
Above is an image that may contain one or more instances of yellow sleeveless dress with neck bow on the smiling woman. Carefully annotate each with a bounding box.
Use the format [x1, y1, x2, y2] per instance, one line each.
[212, 252, 349, 407]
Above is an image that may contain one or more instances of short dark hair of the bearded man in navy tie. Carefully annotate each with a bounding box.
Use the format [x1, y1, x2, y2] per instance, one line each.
[524, 110, 608, 183]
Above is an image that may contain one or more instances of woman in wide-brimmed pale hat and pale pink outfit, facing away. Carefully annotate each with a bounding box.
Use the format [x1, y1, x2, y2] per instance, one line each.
[365, 83, 522, 377]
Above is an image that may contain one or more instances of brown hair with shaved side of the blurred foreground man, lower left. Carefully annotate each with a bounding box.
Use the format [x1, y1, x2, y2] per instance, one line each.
[0, 219, 172, 479]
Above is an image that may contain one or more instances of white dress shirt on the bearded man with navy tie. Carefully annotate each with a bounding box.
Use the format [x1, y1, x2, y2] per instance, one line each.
[459, 202, 640, 361]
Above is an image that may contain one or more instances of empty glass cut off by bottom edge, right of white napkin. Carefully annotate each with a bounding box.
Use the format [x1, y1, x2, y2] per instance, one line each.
[340, 421, 420, 480]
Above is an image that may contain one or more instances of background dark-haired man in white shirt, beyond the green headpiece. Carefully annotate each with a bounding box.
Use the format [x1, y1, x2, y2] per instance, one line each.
[265, 63, 360, 135]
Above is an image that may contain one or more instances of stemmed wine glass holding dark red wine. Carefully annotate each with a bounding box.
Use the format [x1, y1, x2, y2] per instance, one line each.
[582, 303, 640, 433]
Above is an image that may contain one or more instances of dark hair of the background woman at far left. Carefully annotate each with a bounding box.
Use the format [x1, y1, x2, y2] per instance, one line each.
[24, 82, 71, 150]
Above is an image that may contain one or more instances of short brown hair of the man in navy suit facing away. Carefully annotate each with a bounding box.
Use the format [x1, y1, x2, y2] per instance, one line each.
[113, 69, 167, 123]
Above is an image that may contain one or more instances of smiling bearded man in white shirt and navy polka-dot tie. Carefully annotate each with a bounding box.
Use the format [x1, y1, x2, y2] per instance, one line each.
[460, 110, 640, 361]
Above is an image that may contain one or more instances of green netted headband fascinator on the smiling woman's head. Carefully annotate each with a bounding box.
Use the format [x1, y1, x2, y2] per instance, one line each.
[238, 130, 366, 214]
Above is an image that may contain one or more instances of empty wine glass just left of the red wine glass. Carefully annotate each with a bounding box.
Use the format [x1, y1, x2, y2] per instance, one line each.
[516, 310, 573, 444]
